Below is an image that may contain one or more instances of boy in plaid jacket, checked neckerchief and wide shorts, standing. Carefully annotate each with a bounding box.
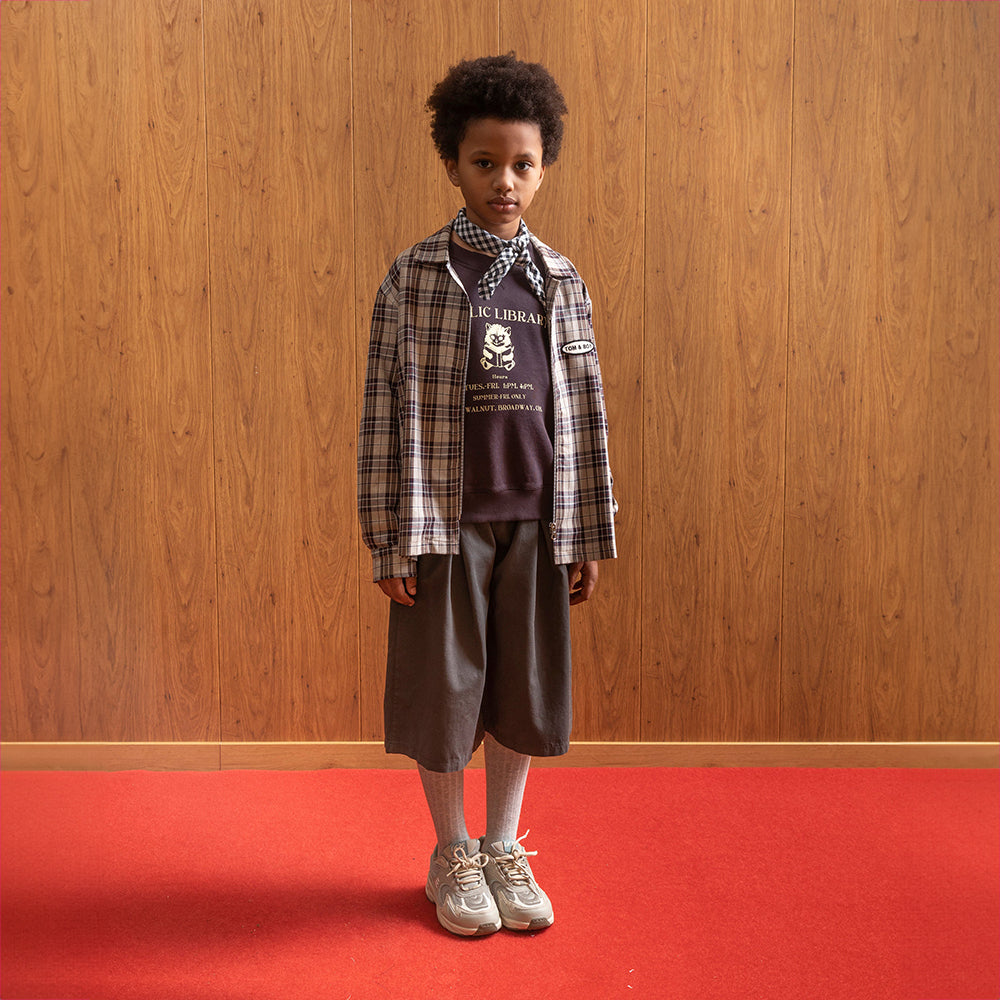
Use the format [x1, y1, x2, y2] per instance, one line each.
[358, 55, 616, 935]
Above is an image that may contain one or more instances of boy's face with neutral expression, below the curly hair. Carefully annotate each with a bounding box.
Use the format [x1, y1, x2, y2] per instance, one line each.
[445, 118, 545, 240]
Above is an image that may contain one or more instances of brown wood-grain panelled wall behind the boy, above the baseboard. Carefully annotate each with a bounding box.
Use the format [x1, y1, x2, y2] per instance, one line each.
[2, 0, 998, 741]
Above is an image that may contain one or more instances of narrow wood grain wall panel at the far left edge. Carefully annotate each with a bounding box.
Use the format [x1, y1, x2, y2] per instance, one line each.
[0, 3, 83, 741]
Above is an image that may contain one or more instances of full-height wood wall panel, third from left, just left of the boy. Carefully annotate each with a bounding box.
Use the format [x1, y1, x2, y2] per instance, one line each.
[206, 0, 358, 739]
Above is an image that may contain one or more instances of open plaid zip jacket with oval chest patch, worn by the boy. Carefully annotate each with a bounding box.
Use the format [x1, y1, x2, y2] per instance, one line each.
[358, 223, 617, 580]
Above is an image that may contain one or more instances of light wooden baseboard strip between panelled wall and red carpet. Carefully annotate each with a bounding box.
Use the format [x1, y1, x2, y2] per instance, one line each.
[0, 742, 1000, 771]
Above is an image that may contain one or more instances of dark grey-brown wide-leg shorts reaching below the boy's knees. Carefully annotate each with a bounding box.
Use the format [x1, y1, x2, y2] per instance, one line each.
[385, 521, 572, 771]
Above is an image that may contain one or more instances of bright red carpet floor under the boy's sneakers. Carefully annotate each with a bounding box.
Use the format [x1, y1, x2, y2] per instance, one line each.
[0, 768, 1000, 1000]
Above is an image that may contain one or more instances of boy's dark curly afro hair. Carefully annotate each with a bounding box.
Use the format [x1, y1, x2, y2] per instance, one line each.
[426, 52, 568, 166]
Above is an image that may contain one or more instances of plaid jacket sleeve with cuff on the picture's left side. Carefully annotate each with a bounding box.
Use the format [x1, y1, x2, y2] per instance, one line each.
[358, 267, 417, 581]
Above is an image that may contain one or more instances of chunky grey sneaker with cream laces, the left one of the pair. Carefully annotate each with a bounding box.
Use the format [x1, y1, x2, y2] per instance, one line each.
[427, 840, 500, 937]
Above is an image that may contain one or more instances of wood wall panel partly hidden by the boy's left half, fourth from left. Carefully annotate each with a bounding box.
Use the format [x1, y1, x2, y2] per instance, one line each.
[352, 0, 498, 739]
